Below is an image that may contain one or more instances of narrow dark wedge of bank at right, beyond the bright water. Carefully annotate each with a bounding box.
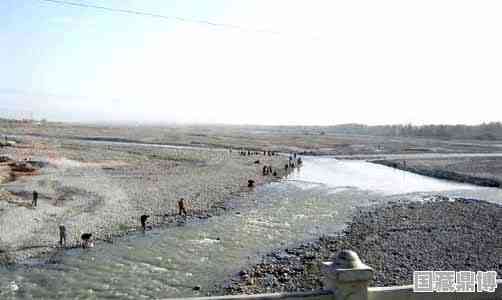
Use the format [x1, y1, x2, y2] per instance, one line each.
[372, 155, 502, 187]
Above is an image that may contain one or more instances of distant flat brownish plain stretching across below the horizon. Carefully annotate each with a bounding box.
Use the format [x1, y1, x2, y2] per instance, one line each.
[0, 120, 502, 155]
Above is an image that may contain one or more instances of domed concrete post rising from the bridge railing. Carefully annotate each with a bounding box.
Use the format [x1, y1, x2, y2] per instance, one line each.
[323, 250, 373, 300]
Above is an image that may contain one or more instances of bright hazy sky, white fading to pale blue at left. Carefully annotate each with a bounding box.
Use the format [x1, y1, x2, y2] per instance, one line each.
[0, 0, 502, 125]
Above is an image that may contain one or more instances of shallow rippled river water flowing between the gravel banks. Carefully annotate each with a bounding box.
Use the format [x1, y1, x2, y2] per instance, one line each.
[0, 157, 502, 299]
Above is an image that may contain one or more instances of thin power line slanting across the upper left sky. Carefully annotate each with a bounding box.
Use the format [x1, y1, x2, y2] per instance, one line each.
[39, 0, 282, 34]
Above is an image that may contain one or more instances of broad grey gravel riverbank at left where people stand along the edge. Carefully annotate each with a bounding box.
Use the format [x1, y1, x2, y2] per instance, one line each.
[0, 137, 287, 264]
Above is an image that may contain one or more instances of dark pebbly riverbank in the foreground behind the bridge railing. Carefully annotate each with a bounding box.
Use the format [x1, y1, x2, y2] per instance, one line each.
[220, 196, 502, 294]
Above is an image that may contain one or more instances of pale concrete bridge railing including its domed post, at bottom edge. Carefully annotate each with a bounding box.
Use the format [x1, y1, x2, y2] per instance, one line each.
[171, 250, 502, 300]
